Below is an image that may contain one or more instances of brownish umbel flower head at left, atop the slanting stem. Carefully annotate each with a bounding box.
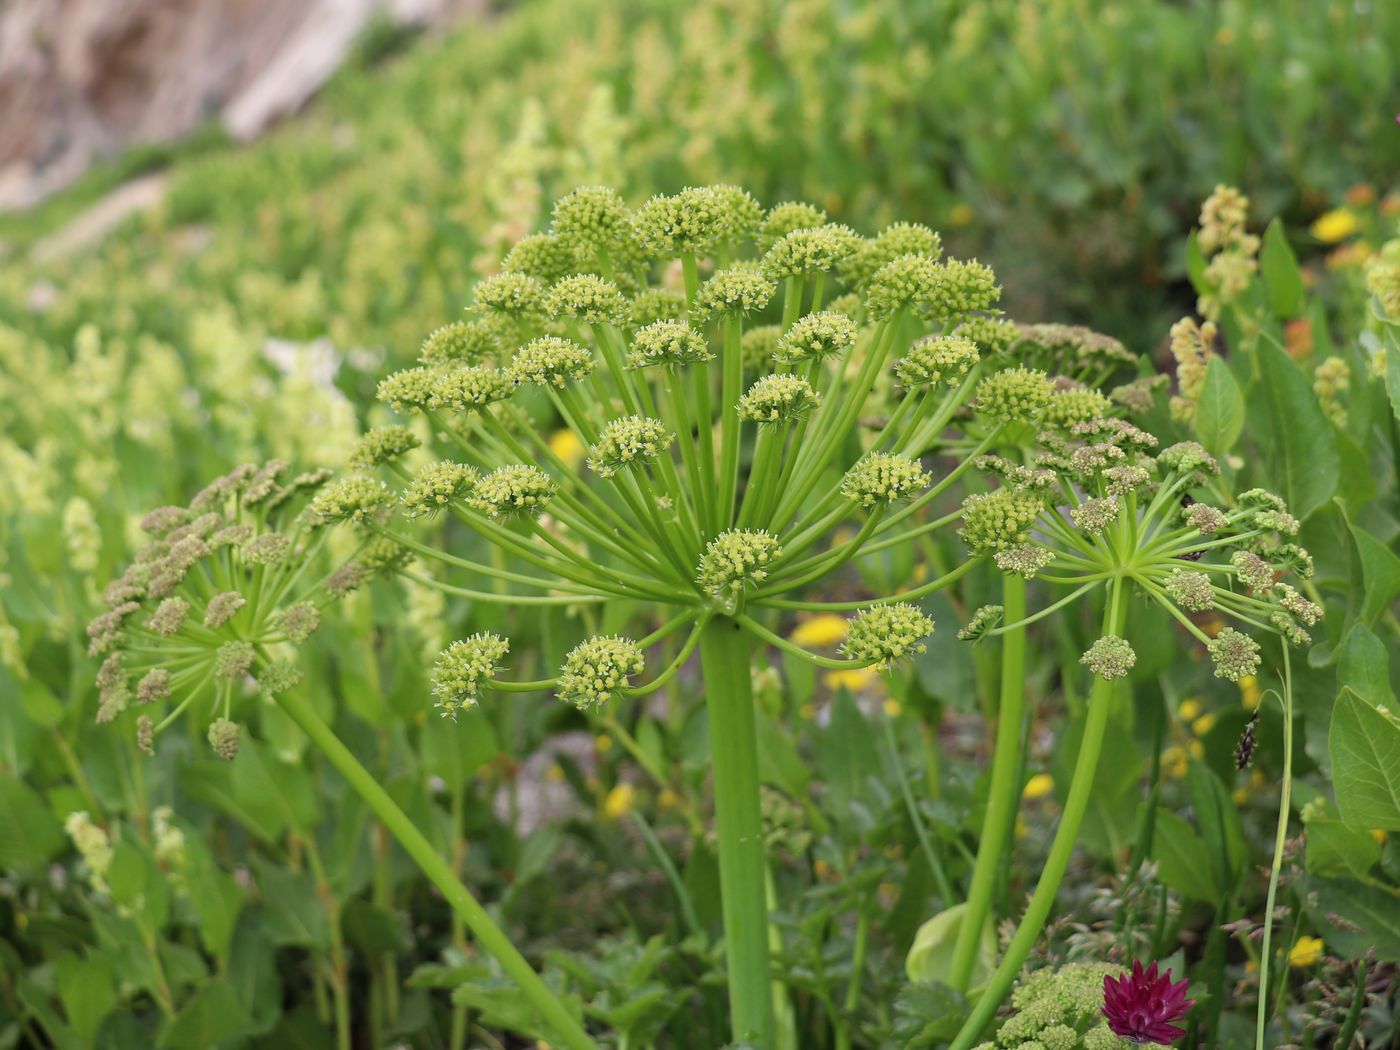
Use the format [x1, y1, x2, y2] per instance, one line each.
[88, 464, 372, 759]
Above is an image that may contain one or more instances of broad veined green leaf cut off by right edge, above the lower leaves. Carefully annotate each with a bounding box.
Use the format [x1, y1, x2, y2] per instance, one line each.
[1327, 687, 1400, 832]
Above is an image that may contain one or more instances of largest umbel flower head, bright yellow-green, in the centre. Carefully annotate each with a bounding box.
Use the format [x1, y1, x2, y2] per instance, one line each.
[324, 186, 1121, 714]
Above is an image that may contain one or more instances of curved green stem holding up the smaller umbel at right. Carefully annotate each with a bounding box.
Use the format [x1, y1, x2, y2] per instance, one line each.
[952, 581, 1127, 1050]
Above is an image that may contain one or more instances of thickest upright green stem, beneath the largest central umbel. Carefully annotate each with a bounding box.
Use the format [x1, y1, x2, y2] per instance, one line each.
[700, 617, 773, 1050]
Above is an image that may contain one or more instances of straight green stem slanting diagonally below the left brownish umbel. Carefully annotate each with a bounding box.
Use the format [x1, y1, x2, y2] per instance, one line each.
[277, 691, 599, 1050]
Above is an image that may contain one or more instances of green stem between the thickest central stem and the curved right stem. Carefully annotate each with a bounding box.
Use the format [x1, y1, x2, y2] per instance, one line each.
[948, 573, 1026, 991]
